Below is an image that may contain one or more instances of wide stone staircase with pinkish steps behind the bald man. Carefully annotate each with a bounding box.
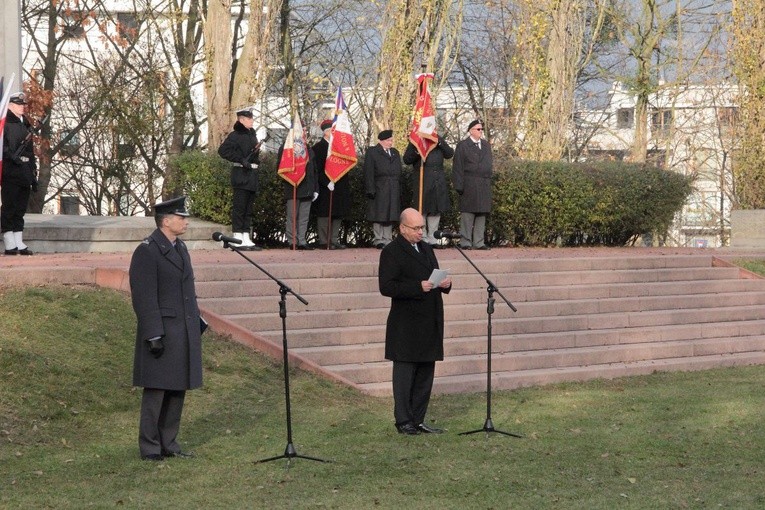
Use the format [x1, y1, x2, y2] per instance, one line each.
[196, 255, 765, 395]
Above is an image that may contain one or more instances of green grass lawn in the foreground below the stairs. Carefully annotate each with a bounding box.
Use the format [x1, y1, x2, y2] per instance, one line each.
[0, 287, 765, 509]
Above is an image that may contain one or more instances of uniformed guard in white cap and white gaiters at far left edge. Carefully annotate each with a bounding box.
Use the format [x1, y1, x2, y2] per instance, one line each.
[0, 92, 37, 255]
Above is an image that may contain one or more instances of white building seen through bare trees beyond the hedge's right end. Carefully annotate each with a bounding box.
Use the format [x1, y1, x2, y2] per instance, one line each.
[574, 83, 739, 247]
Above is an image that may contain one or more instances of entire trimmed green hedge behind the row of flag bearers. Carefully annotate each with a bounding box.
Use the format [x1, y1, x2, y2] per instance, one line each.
[170, 151, 692, 246]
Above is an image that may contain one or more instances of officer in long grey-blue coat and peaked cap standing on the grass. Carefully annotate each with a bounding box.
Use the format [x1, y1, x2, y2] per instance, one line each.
[130, 197, 206, 460]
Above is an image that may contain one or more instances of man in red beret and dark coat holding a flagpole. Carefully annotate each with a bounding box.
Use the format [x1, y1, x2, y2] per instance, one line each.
[312, 119, 352, 250]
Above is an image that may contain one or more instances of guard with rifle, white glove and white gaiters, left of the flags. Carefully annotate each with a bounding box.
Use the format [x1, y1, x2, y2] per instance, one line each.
[218, 108, 260, 250]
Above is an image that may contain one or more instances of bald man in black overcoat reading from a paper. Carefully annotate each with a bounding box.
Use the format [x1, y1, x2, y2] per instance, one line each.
[378, 208, 452, 435]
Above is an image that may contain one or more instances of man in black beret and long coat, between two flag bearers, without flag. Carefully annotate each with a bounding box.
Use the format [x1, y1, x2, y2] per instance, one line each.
[364, 129, 402, 249]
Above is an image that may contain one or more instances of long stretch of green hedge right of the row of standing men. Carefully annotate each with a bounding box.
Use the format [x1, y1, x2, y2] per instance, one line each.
[487, 162, 691, 246]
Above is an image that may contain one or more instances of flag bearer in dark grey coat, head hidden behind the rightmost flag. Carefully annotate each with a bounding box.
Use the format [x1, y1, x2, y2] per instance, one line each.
[404, 136, 454, 247]
